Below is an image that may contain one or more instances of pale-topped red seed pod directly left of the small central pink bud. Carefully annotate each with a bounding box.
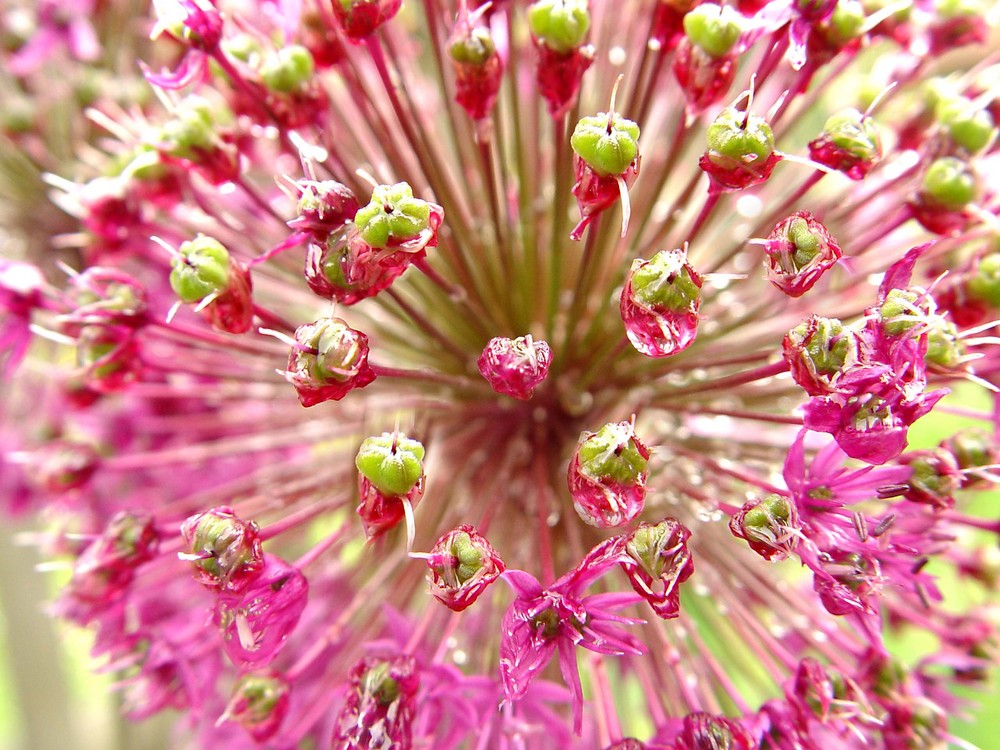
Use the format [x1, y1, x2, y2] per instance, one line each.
[284, 318, 375, 406]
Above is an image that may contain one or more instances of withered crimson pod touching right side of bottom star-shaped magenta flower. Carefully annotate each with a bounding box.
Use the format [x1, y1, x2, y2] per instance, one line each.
[621, 518, 694, 620]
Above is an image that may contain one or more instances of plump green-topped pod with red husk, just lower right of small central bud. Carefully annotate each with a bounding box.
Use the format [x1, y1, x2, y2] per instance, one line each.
[567, 422, 649, 529]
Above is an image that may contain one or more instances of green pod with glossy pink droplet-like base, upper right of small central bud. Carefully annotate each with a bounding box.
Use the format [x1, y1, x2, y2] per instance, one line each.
[619, 249, 702, 358]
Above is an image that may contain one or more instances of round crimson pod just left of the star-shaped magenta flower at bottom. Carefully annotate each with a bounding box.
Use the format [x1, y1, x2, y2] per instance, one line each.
[427, 524, 506, 612]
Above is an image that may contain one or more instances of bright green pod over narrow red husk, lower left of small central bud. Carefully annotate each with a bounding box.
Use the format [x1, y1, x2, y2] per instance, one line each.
[355, 432, 424, 539]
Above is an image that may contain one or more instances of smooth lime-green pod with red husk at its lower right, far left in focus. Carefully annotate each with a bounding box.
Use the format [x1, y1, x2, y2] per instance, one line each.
[170, 235, 253, 333]
